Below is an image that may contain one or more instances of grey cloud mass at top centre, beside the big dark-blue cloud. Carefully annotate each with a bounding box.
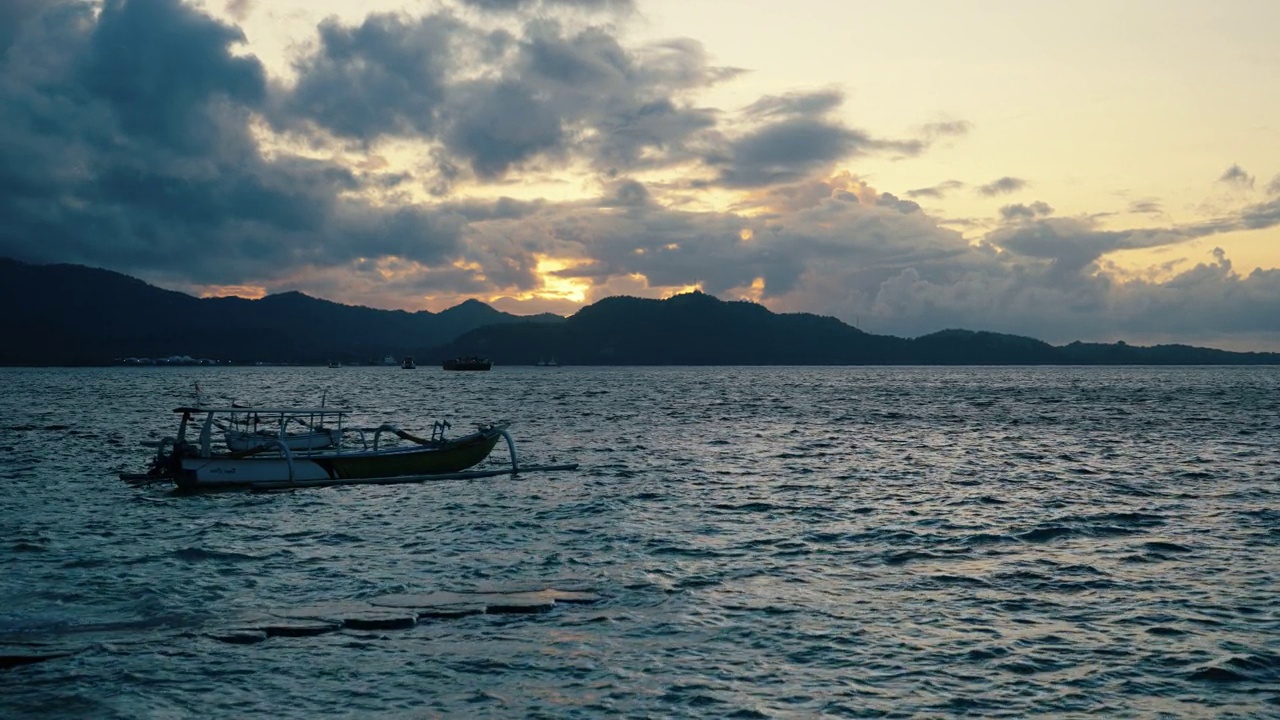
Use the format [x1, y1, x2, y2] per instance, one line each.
[274, 13, 737, 179]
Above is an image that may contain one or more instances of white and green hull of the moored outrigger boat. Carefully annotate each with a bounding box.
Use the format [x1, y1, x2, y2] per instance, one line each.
[175, 428, 502, 489]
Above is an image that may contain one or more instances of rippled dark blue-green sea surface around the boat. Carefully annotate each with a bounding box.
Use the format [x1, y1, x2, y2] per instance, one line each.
[0, 366, 1280, 717]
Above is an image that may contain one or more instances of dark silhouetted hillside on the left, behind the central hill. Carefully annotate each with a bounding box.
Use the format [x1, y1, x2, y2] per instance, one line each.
[0, 259, 563, 365]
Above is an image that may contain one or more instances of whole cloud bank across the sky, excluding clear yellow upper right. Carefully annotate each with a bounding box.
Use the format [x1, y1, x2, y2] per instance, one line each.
[0, 0, 1280, 347]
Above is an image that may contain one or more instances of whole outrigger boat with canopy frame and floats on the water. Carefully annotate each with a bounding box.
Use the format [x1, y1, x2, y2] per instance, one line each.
[120, 405, 577, 491]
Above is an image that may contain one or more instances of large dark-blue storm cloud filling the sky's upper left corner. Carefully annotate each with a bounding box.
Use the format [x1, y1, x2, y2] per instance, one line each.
[0, 0, 460, 283]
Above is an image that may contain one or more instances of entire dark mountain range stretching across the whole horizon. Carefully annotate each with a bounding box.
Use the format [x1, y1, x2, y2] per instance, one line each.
[0, 258, 1280, 366]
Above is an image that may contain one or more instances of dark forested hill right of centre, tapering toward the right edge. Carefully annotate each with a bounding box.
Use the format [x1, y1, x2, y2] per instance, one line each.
[436, 292, 1280, 365]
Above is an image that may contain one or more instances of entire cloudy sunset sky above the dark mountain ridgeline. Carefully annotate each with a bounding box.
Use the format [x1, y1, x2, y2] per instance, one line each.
[0, 0, 1280, 351]
